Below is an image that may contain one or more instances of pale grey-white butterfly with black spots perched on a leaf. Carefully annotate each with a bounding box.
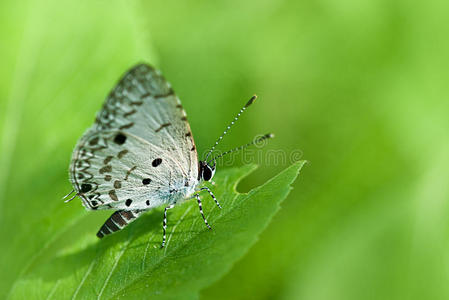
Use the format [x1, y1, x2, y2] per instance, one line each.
[64, 64, 273, 247]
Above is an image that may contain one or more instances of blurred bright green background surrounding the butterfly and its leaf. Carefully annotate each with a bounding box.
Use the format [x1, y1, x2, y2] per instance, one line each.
[0, 0, 449, 299]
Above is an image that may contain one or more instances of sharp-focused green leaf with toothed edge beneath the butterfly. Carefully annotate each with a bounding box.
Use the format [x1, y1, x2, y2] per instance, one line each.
[10, 161, 304, 299]
